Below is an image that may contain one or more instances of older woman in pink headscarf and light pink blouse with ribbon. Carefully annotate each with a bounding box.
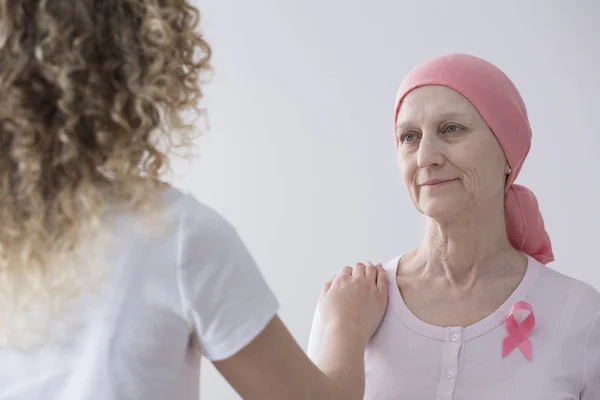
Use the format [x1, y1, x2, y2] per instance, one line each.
[309, 54, 600, 400]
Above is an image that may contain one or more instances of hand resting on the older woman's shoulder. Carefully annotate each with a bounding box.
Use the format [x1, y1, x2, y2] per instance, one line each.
[319, 262, 388, 345]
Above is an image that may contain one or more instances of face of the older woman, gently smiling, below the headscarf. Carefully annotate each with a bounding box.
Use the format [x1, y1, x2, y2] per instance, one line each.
[396, 86, 508, 219]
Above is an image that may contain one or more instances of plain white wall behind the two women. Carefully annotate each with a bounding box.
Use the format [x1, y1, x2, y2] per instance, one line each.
[175, 0, 600, 400]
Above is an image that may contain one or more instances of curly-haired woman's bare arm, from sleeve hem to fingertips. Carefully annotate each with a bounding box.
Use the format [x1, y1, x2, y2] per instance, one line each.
[214, 264, 387, 400]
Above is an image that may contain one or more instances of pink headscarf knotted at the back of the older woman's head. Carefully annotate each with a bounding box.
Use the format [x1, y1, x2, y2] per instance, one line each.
[394, 54, 554, 264]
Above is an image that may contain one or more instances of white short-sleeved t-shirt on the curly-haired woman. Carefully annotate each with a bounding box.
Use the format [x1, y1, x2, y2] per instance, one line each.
[0, 189, 278, 400]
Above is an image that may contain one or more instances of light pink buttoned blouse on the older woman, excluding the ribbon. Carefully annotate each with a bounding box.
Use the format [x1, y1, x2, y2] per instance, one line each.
[308, 257, 600, 400]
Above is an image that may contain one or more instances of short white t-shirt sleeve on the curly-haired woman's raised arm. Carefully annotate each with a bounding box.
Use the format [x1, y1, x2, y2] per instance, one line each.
[179, 199, 279, 361]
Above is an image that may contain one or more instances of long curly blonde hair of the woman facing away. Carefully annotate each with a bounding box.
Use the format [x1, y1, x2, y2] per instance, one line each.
[0, 0, 211, 345]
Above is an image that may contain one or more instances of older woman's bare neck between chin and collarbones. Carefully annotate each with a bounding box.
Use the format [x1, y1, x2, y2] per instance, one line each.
[417, 207, 526, 286]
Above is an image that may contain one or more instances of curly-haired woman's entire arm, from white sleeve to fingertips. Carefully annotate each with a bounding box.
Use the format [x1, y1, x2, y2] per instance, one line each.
[177, 199, 387, 400]
